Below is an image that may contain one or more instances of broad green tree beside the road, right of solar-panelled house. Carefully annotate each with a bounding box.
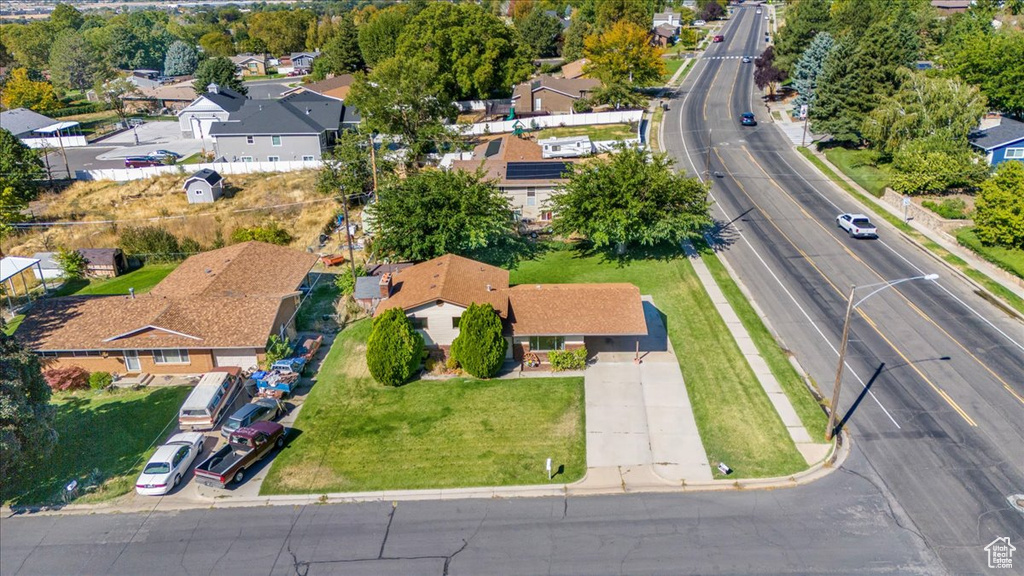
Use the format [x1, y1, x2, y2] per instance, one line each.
[551, 148, 712, 253]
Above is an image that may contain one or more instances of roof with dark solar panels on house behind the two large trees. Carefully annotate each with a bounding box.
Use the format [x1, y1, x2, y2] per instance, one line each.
[452, 134, 571, 186]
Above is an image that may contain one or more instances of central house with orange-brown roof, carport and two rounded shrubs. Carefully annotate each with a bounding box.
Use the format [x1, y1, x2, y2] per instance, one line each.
[374, 254, 647, 362]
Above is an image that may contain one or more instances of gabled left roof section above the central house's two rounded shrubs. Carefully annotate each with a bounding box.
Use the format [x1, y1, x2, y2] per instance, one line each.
[377, 254, 509, 318]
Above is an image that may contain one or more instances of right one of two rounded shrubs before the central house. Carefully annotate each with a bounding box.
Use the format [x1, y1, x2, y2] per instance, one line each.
[452, 303, 508, 378]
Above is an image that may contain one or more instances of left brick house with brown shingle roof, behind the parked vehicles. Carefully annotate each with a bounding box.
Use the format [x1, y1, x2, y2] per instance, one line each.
[17, 242, 316, 374]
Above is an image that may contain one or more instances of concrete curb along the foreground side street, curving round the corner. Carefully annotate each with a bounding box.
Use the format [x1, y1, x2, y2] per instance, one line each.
[0, 433, 851, 518]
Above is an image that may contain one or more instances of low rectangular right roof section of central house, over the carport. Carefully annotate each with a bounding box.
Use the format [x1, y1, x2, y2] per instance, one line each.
[508, 284, 647, 336]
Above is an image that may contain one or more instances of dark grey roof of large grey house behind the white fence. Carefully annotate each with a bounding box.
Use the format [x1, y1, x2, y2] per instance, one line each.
[210, 92, 344, 136]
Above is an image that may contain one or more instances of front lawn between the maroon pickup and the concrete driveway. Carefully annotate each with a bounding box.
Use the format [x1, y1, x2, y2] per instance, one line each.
[260, 320, 587, 494]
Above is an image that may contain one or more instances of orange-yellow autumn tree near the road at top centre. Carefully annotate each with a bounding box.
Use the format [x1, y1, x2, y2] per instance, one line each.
[584, 20, 666, 88]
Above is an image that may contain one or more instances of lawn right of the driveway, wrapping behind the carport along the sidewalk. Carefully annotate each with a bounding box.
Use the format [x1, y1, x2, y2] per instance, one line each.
[511, 247, 807, 478]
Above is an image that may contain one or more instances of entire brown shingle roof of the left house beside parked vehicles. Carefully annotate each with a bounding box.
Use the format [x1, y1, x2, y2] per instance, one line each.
[17, 242, 316, 351]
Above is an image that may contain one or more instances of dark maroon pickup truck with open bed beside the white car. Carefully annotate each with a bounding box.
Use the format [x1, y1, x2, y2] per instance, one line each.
[196, 416, 285, 488]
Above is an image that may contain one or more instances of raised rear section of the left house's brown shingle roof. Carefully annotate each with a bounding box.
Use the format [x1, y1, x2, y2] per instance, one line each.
[152, 242, 316, 297]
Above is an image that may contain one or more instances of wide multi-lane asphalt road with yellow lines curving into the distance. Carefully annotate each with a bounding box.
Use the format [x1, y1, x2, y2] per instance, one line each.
[662, 7, 1024, 573]
